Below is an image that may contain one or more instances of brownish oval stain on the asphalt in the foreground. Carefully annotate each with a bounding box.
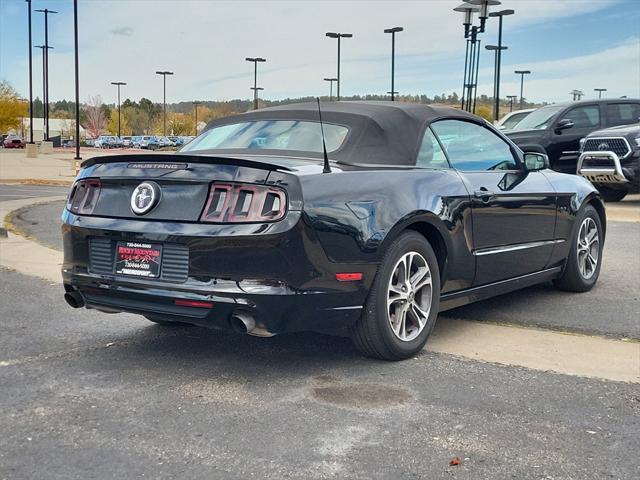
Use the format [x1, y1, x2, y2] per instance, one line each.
[309, 378, 413, 409]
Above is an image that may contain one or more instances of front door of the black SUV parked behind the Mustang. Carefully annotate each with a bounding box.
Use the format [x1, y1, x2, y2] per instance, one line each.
[549, 103, 601, 174]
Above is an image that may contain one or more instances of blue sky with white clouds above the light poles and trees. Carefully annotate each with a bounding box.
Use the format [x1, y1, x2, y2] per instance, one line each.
[0, 0, 640, 103]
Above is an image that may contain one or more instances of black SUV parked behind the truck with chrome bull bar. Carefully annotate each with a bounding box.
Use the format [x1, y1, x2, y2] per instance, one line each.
[506, 98, 640, 174]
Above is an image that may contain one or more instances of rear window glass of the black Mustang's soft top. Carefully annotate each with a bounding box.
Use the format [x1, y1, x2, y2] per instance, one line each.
[181, 120, 349, 152]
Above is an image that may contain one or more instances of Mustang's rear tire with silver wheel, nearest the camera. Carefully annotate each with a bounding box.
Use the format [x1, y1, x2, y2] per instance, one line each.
[350, 231, 440, 360]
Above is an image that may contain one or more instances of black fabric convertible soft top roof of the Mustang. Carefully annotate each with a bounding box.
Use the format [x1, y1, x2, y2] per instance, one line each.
[206, 102, 481, 165]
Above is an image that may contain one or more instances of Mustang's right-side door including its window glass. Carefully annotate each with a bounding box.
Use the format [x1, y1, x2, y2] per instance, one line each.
[431, 120, 556, 285]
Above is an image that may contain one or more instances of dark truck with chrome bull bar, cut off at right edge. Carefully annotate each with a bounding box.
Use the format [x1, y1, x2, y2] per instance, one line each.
[578, 123, 640, 202]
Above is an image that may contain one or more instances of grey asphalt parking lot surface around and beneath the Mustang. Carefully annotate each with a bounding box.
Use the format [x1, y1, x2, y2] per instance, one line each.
[0, 185, 640, 479]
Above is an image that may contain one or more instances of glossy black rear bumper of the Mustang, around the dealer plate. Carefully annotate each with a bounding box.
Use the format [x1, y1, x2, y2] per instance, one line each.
[62, 208, 377, 333]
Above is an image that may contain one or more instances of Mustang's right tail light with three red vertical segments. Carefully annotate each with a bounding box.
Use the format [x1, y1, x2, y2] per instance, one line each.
[200, 182, 287, 223]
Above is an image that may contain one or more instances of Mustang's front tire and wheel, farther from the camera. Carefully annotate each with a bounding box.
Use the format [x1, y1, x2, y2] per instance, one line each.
[554, 205, 604, 292]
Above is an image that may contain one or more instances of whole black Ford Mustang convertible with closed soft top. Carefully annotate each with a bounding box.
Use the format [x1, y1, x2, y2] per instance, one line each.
[62, 102, 606, 359]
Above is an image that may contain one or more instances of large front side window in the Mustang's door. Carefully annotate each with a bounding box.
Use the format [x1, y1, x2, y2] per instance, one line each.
[431, 120, 518, 171]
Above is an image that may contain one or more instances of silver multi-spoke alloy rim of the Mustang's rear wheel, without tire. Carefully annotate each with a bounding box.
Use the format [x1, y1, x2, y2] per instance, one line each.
[387, 252, 433, 342]
